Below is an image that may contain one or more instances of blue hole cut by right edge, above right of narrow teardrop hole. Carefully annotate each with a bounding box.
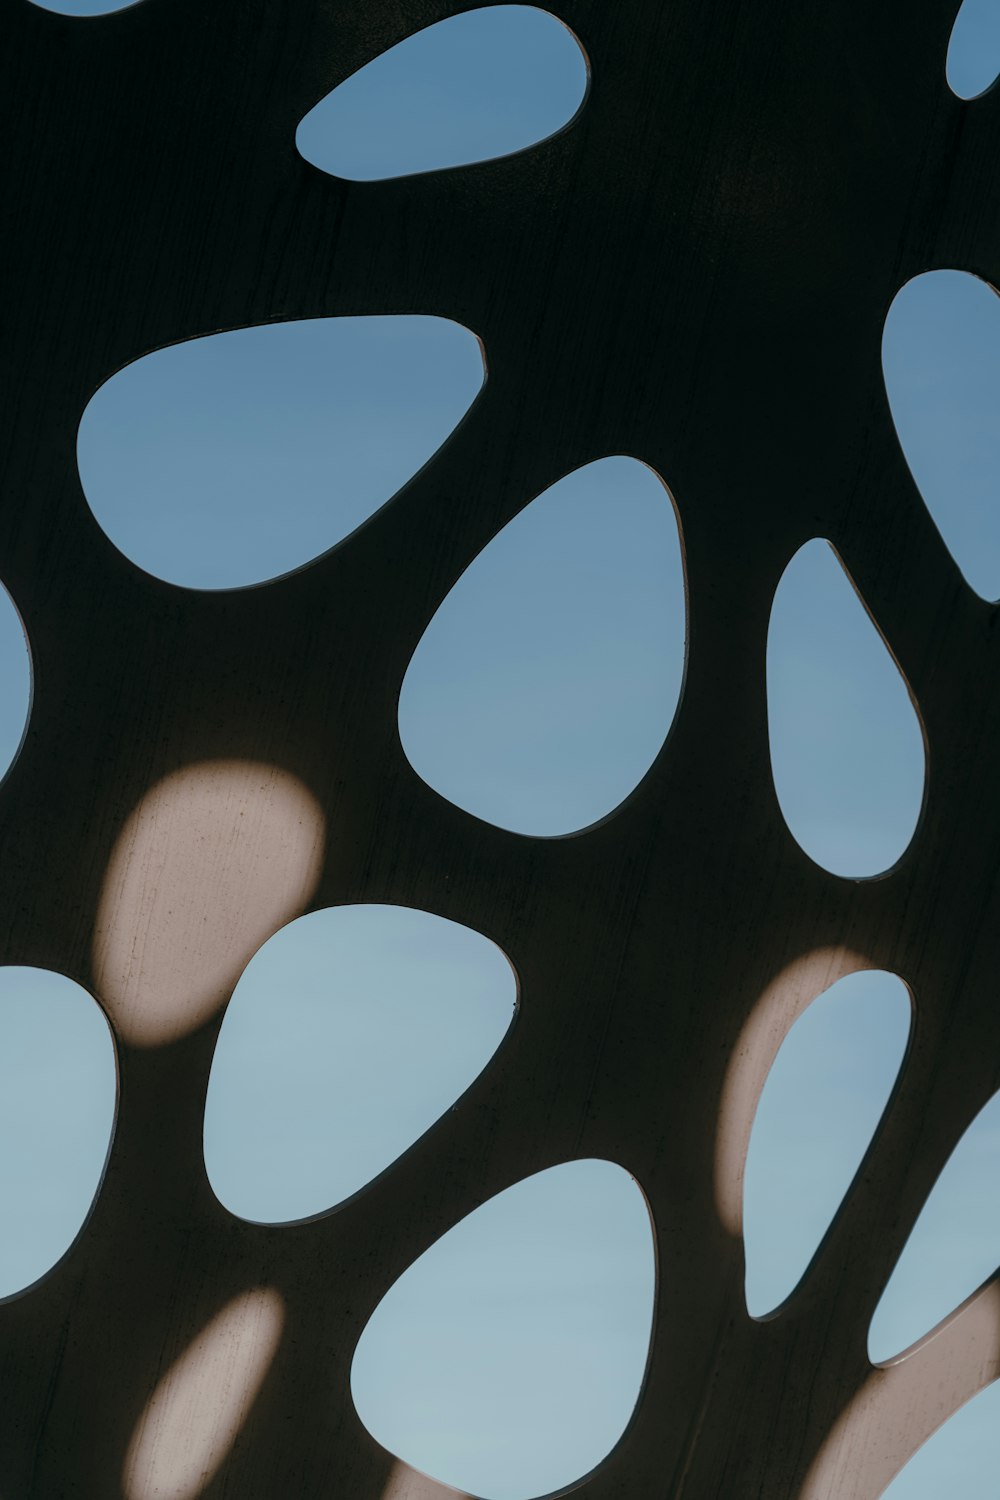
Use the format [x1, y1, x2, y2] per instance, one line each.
[882, 270, 1000, 599]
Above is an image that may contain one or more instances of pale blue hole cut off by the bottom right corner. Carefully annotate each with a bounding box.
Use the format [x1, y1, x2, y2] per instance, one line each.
[882, 1382, 1000, 1500]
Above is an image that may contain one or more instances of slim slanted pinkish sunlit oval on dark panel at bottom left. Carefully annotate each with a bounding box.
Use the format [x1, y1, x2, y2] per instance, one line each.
[121, 1289, 285, 1500]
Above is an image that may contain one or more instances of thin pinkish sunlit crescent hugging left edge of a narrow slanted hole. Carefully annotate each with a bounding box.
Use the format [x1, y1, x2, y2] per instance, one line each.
[715, 948, 871, 1235]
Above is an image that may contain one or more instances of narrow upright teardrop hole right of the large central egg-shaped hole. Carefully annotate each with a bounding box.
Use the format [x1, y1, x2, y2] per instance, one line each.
[768, 540, 925, 876]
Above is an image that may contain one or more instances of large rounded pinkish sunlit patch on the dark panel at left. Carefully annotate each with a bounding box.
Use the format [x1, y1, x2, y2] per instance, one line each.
[93, 761, 325, 1047]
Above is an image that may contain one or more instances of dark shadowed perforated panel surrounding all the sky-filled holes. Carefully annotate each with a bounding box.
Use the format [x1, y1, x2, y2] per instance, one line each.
[0, 0, 1000, 1500]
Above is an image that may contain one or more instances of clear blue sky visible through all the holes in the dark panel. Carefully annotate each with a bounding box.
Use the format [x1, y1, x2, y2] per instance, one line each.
[0, 0, 1000, 1500]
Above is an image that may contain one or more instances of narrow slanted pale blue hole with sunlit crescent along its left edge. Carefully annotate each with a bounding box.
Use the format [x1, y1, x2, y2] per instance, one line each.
[744, 969, 910, 1317]
